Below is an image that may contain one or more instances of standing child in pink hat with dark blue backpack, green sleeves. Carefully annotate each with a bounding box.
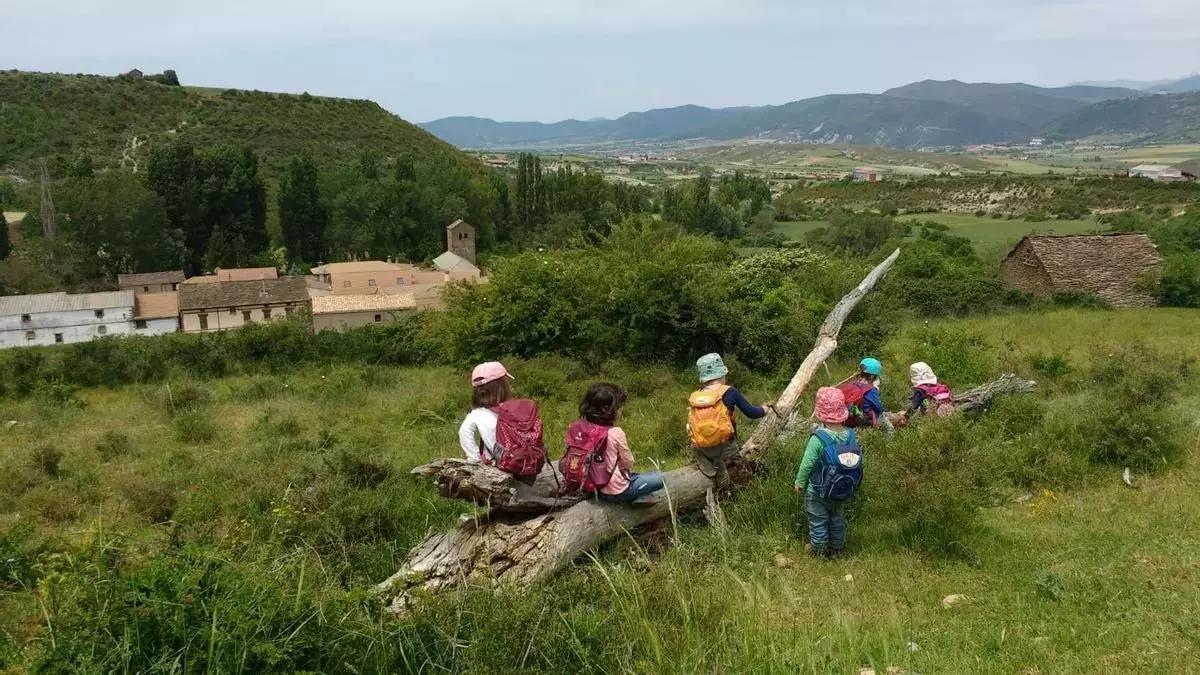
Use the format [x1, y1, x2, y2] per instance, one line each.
[793, 387, 863, 556]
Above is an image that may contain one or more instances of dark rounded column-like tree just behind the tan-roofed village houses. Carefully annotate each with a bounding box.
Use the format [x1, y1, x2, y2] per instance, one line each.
[278, 157, 329, 263]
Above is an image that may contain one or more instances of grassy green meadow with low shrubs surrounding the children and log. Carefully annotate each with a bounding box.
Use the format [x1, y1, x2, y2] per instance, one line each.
[0, 310, 1200, 673]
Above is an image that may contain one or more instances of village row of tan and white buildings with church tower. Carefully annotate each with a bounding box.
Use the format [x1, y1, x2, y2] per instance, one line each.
[0, 220, 477, 348]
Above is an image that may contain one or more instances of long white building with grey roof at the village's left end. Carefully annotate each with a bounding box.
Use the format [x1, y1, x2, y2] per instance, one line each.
[0, 291, 133, 347]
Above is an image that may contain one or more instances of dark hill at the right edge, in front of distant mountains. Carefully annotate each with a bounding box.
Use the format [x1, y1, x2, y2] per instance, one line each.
[1044, 92, 1200, 143]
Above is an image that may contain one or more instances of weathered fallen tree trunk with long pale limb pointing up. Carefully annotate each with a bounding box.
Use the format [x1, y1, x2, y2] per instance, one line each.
[376, 249, 900, 614]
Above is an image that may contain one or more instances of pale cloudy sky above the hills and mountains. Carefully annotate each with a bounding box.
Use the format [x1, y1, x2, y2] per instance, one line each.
[9, 0, 1200, 121]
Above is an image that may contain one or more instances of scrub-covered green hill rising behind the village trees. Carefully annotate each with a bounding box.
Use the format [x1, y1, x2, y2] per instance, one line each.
[0, 71, 472, 173]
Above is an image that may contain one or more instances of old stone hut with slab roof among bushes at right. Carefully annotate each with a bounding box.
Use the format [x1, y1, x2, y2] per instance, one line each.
[1001, 234, 1163, 307]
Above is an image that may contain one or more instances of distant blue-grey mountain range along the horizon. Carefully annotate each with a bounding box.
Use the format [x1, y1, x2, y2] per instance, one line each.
[420, 80, 1200, 148]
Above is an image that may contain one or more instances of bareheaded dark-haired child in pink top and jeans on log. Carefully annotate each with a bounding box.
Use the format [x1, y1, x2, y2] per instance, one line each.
[580, 382, 662, 504]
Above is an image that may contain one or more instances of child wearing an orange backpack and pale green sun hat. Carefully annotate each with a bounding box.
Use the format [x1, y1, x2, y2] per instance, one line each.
[688, 354, 773, 488]
